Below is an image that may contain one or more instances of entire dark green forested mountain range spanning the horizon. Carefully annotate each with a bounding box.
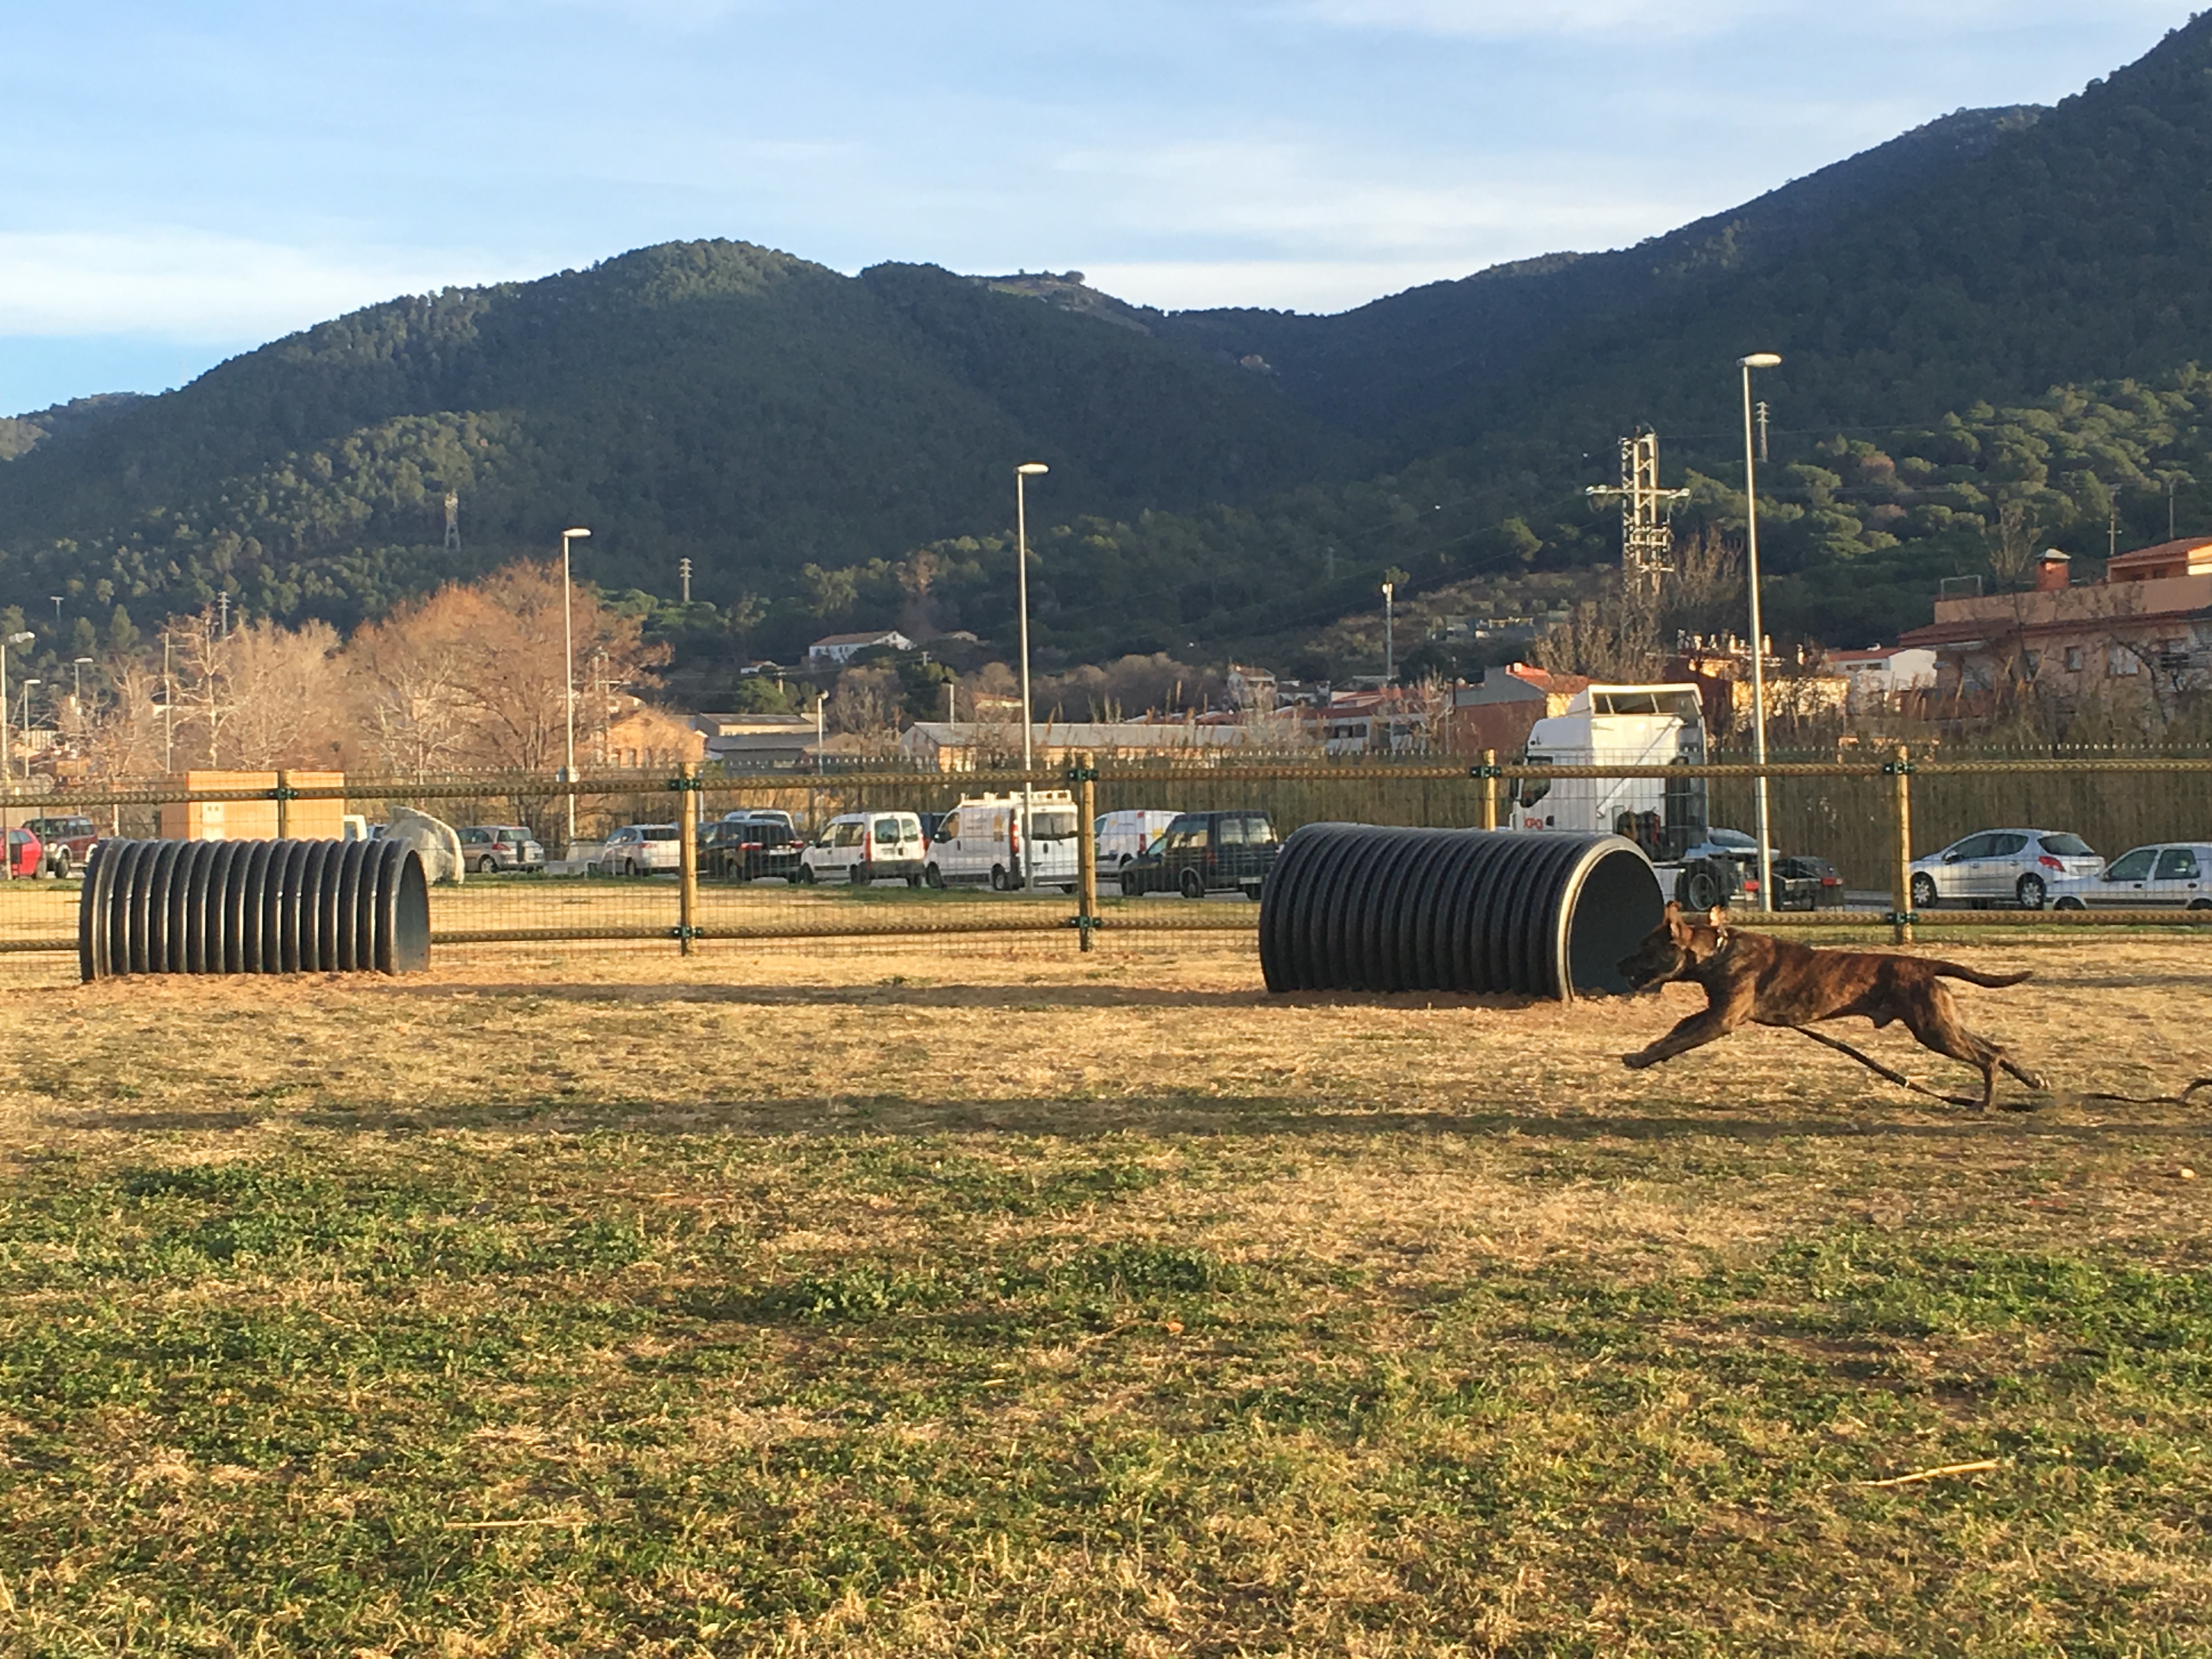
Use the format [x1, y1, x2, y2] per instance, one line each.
[0, 13, 2212, 676]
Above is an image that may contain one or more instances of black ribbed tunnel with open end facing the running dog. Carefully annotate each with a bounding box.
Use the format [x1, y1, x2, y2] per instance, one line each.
[1259, 823, 1663, 1002]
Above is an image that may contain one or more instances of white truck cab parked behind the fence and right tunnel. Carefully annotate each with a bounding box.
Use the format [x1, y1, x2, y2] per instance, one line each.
[1498, 686, 1706, 898]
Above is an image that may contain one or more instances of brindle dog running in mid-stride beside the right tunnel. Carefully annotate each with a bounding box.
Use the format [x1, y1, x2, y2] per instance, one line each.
[1619, 905, 2044, 1113]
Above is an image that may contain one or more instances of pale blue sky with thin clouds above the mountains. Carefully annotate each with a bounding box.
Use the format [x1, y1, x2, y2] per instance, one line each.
[0, 0, 2188, 411]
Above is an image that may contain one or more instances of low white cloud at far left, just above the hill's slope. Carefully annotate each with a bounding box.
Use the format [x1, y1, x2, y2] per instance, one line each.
[0, 228, 520, 341]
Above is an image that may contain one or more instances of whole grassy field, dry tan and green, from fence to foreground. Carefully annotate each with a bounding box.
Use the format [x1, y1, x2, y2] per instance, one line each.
[0, 938, 2212, 1657]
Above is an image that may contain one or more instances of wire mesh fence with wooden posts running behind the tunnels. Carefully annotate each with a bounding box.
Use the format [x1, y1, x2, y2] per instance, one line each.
[0, 752, 2212, 982]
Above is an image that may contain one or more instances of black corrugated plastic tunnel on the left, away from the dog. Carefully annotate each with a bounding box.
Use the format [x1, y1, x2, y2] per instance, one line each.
[77, 840, 429, 980]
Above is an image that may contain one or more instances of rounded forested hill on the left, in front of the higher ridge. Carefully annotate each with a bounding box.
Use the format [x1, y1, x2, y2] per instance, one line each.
[0, 241, 1361, 641]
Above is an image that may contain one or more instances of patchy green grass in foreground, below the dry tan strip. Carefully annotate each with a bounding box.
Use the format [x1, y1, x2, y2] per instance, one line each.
[0, 1130, 2212, 1657]
